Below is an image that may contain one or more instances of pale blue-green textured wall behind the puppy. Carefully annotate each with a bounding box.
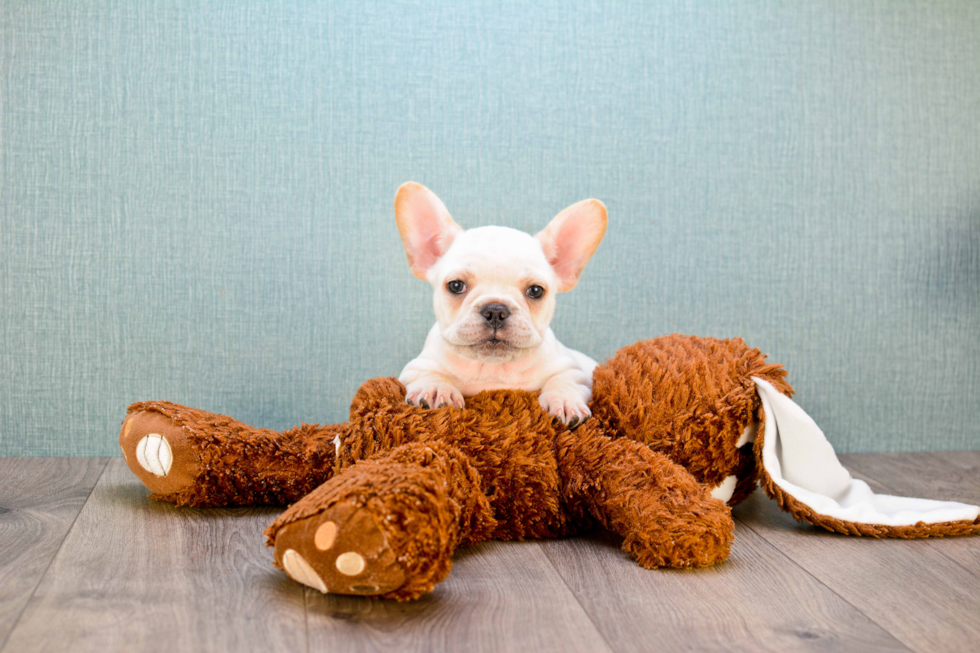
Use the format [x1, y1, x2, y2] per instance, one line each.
[0, 0, 980, 455]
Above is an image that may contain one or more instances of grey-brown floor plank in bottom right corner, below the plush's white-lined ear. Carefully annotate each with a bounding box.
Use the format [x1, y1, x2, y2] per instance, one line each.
[737, 454, 980, 652]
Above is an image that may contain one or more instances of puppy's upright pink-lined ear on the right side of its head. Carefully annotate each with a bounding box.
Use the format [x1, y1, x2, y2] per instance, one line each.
[534, 200, 606, 292]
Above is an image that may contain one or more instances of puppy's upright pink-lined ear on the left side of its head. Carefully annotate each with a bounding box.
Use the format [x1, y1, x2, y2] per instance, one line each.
[395, 181, 463, 279]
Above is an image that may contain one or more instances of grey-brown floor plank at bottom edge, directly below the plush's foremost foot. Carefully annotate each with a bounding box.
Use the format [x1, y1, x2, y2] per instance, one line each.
[307, 541, 610, 652]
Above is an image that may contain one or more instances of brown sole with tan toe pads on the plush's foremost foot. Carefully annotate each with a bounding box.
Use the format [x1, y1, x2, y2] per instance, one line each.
[275, 502, 406, 596]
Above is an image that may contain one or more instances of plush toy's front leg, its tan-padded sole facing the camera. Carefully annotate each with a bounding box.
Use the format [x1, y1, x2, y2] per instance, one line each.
[266, 443, 496, 600]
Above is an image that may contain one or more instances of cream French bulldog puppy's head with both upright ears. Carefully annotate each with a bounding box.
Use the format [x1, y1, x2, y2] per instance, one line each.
[395, 182, 606, 362]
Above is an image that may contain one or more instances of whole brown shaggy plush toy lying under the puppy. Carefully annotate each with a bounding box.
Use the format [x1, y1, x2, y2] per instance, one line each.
[119, 335, 980, 600]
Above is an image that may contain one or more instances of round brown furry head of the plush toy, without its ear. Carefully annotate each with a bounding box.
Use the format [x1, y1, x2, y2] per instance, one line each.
[592, 334, 793, 505]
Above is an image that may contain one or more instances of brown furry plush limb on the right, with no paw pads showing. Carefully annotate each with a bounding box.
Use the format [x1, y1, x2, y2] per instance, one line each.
[558, 422, 734, 568]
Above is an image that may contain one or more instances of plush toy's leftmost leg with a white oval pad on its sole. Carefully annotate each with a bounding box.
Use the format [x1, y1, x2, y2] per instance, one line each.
[119, 401, 347, 507]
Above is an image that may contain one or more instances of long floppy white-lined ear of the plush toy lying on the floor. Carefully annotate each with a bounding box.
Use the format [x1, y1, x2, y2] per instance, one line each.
[752, 377, 980, 538]
